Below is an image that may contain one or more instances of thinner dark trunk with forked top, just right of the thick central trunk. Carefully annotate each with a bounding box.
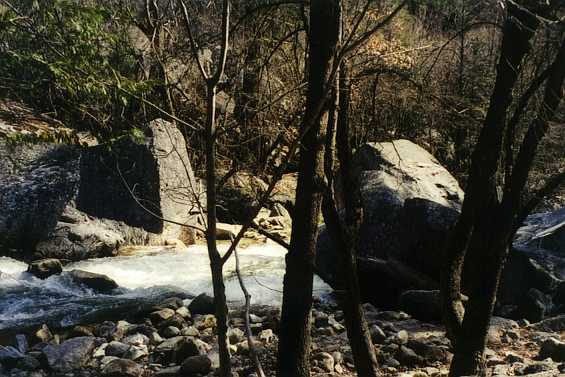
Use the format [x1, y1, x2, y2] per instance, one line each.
[322, 64, 378, 377]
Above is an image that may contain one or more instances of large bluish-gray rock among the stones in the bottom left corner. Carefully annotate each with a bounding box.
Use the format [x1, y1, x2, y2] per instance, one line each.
[42, 337, 97, 372]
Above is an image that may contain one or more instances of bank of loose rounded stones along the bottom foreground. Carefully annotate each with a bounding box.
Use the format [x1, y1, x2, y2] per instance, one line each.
[0, 295, 565, 377]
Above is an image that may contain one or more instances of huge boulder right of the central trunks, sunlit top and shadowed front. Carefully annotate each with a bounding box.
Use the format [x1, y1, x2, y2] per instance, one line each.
[316, 140, 463, 306]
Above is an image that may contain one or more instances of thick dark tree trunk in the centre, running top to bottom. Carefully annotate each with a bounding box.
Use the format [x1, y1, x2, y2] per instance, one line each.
[278, 0, 340, 377]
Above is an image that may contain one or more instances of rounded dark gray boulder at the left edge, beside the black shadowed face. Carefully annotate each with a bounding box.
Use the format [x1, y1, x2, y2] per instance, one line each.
[0, 140, 80, 256]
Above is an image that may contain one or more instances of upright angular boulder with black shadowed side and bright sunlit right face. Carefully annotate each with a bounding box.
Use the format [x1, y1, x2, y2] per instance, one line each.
[77, 119, 201, 245]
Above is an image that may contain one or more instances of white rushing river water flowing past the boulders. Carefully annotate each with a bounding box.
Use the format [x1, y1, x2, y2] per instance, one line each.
[0, 243, 330, 331]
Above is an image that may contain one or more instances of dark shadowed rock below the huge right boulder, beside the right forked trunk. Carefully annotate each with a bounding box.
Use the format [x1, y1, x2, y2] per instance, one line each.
[399, 290, 441, 321]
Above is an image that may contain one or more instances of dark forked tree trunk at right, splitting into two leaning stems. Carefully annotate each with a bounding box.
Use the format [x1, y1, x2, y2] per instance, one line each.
[442, 3, 565, 376]
